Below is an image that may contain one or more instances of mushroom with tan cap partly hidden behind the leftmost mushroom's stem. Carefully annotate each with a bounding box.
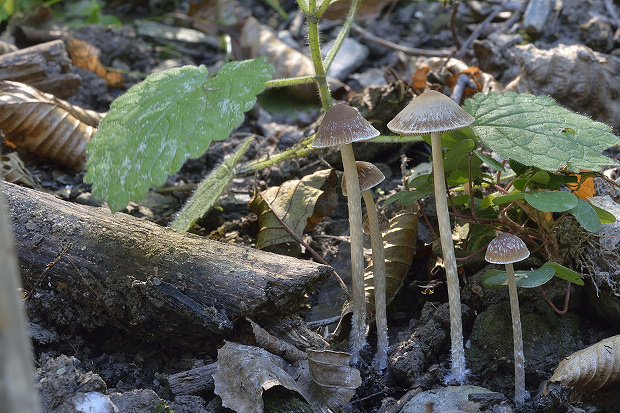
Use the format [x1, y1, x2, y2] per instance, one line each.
[342, 161, 389, 370]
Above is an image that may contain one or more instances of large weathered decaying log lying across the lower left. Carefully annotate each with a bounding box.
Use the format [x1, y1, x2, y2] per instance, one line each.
[2, 183, 333, 349]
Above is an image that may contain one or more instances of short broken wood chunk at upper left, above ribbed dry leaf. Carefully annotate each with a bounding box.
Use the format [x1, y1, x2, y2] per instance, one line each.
[0, 40, 82, 99]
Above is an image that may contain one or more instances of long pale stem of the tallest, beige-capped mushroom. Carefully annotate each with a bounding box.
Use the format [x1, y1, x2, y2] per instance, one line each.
[431, 132, 467, 383]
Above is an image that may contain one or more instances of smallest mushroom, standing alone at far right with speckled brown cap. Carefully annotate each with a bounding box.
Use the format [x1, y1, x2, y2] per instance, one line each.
[484, 232, 530, 404]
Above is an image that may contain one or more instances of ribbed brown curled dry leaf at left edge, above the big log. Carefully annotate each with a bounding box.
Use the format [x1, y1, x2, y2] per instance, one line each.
[0, 81, 103, 170]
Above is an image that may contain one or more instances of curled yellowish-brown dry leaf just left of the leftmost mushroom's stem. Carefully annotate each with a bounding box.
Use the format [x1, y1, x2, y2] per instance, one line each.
[250, 169, 338, 254]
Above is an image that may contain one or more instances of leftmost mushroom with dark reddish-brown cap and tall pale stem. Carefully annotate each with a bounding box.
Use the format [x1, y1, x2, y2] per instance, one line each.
[311, 104, 379, 364]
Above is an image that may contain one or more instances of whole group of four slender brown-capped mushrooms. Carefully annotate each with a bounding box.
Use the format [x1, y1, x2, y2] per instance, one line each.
[312, 90, 529, 403]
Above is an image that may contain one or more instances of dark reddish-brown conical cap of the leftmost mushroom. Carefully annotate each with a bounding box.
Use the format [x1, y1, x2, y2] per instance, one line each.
[311, 103, 380, 148]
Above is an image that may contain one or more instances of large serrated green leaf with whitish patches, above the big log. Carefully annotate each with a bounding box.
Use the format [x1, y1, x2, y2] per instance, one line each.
[84, 58, 274, 211]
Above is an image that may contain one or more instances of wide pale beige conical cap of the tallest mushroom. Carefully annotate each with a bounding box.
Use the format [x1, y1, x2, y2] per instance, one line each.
[387, 89, 475, 135]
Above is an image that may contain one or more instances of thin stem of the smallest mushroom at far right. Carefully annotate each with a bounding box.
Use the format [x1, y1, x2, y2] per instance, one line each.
[506, 264, 527, 404]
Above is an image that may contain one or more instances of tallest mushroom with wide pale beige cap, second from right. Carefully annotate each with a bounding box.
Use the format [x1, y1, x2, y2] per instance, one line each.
[387, 90, 475, 383]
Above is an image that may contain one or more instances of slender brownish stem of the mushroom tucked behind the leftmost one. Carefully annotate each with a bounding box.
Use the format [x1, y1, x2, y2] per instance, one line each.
[362, 190, 389, 370]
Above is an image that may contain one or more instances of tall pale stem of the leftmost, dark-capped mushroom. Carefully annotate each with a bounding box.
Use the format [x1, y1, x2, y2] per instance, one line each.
[340, 144, 366, 364]
